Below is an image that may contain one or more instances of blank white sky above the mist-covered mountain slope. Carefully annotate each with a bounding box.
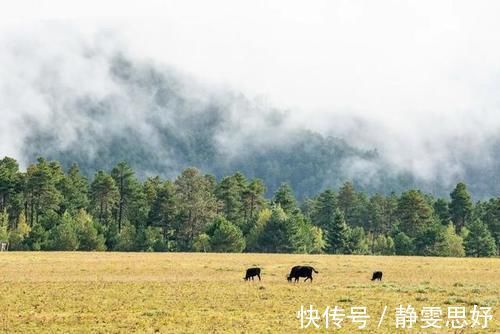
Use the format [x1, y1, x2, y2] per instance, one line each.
[0, 0, 500, 177]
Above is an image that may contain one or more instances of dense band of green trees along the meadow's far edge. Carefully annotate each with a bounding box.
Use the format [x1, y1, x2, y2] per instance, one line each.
[0, 157, 500, 257]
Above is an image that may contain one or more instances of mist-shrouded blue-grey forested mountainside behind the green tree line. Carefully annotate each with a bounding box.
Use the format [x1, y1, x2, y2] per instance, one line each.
[0, 27, 500, 199]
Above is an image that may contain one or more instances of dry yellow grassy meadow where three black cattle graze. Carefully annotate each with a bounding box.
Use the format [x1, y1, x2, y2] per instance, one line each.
[0, 252, 500, 333]
